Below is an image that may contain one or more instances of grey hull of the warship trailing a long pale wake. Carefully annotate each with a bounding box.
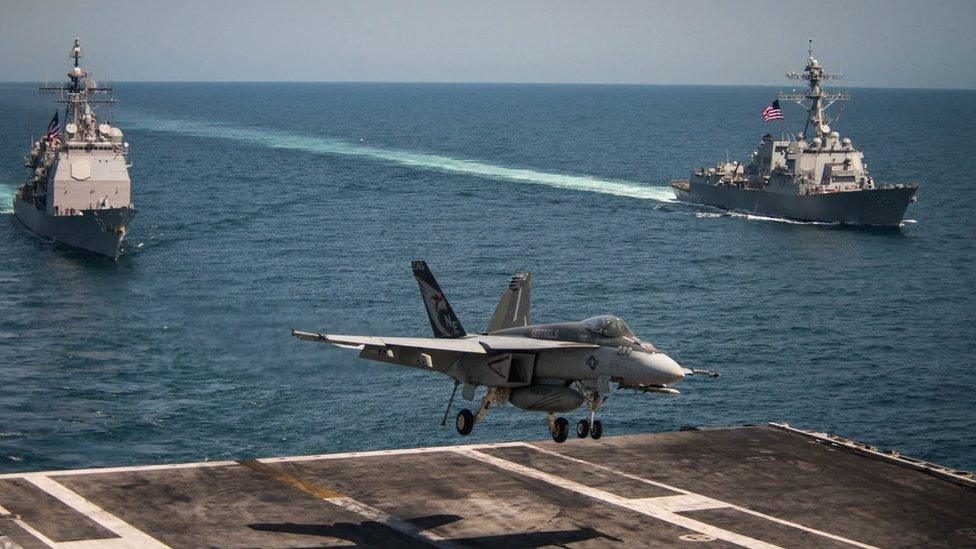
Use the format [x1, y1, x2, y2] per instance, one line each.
[671, 180, 917, 227]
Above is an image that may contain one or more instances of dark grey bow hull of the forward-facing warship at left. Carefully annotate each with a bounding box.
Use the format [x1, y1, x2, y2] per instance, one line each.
[14, 195, 136, 258]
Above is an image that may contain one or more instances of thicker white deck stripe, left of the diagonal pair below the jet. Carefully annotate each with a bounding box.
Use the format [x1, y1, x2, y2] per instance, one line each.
[458, 450, 779, 549]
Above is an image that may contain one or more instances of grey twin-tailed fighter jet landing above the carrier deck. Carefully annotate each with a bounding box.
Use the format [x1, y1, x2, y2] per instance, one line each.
[292, 261, 718, 442]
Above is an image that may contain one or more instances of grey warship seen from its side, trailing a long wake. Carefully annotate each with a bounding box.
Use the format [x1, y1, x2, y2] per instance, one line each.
[669, 39, 918, 226]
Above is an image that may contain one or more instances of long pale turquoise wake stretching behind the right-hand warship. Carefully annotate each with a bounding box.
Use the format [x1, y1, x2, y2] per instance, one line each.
[125, 115, 674, 202]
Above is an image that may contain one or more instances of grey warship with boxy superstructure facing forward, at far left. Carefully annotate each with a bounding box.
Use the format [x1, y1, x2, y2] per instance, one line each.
[13, 38, 136, 258]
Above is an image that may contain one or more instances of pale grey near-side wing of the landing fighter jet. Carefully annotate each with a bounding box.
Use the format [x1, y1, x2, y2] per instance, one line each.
[292, 330, 599, 355]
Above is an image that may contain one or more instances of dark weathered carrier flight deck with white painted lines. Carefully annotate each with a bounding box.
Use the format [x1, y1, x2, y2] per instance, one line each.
[0, 427, 976, 548]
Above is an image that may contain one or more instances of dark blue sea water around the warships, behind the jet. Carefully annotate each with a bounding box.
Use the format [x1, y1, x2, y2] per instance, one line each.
[0, 83, 976, 471]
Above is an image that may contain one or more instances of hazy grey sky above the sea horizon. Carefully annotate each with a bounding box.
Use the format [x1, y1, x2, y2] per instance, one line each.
[0, 0, 976, 88]
